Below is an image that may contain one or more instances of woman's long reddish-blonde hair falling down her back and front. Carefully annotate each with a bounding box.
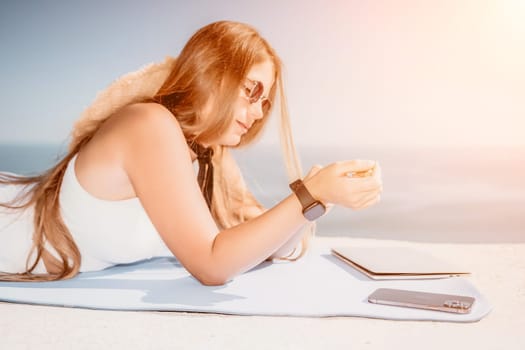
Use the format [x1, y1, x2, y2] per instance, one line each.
[0, 21, 313, 281]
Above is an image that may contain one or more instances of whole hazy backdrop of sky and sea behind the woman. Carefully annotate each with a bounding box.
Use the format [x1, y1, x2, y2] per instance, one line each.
[0, 0, 525, 243]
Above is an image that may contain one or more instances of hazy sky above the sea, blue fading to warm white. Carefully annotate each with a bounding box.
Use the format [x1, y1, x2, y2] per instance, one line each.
[0, 0, 525, 147]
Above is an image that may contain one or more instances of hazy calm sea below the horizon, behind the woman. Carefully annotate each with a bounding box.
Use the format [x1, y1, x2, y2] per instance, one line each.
[0, 143, 525, 243]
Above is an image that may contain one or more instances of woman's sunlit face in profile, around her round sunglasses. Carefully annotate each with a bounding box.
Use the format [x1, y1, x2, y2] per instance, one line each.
[217, 60, 275, 146]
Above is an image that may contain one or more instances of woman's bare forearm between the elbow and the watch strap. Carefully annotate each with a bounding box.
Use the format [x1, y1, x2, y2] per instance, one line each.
[211, 195, 307, 283]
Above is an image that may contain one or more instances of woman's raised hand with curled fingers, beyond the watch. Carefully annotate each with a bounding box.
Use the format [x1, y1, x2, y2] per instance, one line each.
[304, 160, 383, 210]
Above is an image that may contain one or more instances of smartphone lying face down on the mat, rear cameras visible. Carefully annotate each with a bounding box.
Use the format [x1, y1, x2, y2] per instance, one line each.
[368, 288, 476, 314]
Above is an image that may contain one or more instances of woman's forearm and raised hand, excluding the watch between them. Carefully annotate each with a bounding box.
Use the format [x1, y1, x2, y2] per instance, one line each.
[190, 161, 381, 284]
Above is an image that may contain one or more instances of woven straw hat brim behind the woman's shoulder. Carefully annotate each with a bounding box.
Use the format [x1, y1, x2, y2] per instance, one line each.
[69, 56, 175, 150]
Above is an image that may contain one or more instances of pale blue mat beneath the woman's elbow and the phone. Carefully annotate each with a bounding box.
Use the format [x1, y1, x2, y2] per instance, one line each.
[0, 245, 490, 322]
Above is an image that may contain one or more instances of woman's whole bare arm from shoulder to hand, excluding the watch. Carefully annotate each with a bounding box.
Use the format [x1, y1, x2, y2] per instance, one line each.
[122, 106, 378, 284]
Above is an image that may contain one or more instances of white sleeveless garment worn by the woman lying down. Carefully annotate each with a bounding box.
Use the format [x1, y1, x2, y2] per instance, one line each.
[0, 156, 172, 273]
